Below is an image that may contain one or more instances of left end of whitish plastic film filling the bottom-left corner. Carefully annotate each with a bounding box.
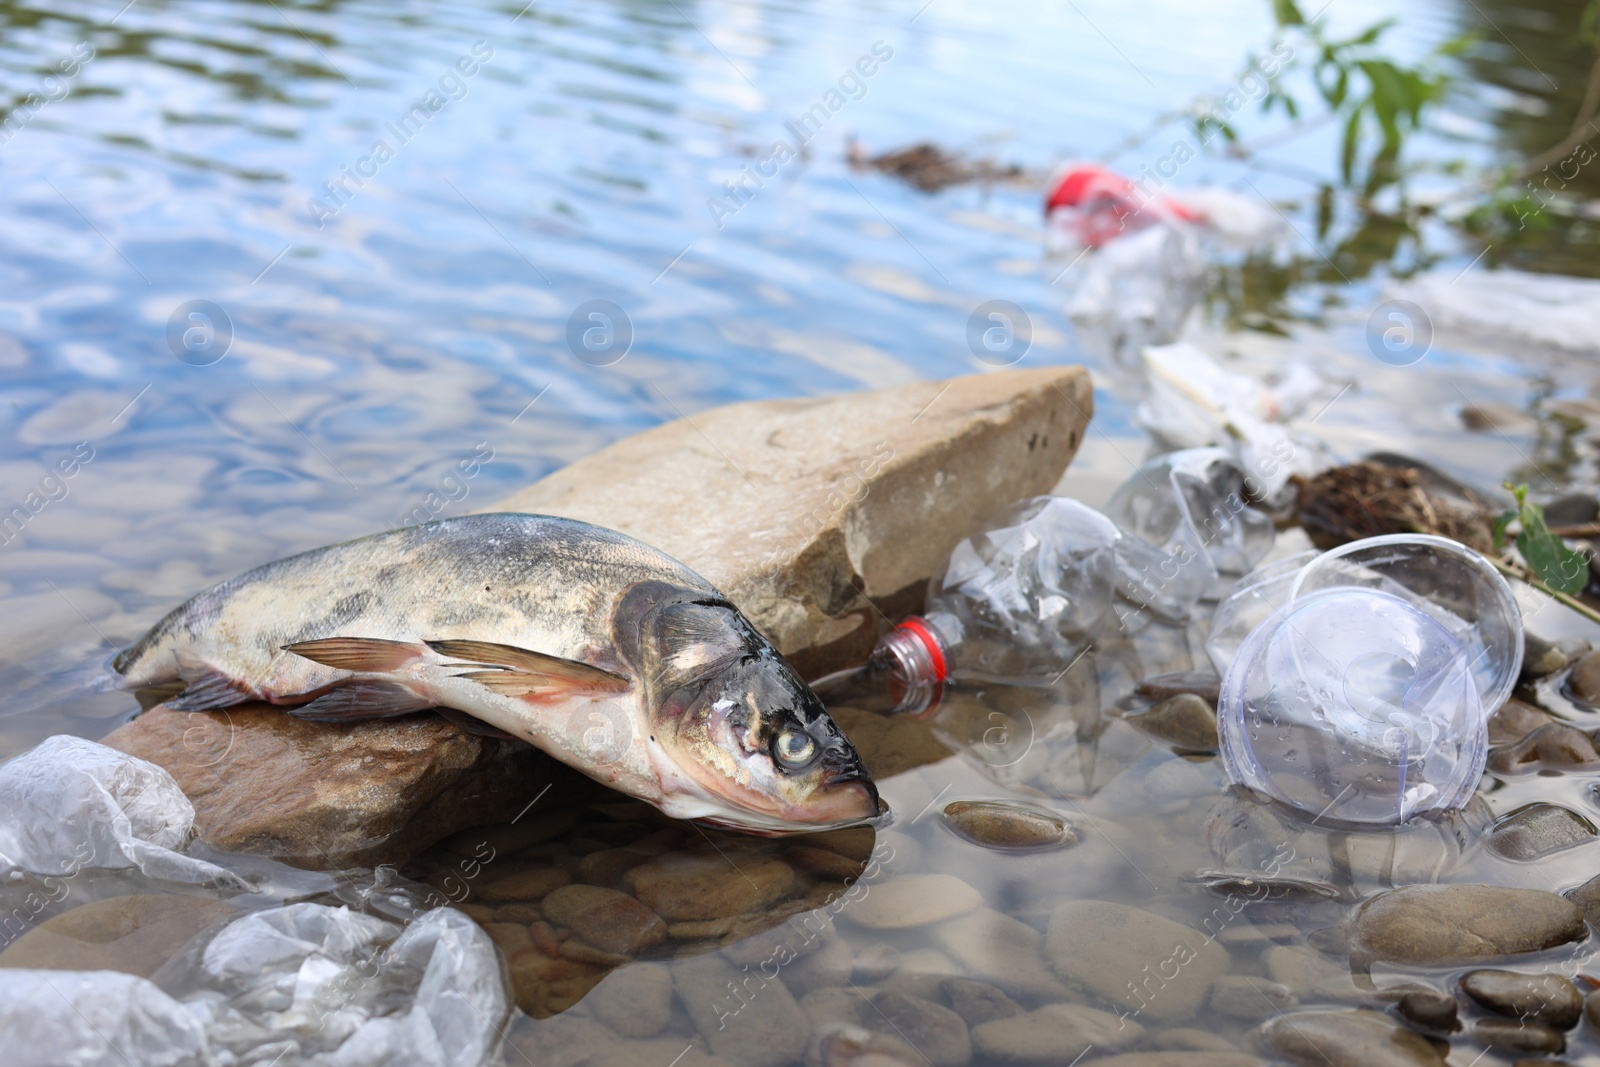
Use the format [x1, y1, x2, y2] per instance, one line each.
[0, 968, 216, 1067]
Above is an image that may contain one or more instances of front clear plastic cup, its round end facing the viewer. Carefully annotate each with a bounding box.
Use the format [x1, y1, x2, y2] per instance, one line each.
[1218, 585, 1488, 825]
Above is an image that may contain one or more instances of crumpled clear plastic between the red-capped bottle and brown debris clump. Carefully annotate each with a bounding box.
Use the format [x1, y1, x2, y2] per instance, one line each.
[1106, 448, 1275, 598]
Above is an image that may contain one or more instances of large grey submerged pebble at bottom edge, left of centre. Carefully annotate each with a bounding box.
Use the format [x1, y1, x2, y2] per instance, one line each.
[672, 953, 811, 1067]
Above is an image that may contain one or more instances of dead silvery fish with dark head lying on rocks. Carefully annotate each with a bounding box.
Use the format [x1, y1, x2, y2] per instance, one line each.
[112, 514, 880, 835]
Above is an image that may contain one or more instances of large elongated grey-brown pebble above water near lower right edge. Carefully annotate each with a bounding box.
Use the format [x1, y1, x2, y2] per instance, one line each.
[1350, 885, 1589, 966]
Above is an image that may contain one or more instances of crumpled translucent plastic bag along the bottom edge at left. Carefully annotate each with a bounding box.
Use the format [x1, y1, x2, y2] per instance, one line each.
[0, 904, 509, 1067]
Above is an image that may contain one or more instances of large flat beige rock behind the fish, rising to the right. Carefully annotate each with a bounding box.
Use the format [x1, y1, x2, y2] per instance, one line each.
[483, 366, 1094, 678]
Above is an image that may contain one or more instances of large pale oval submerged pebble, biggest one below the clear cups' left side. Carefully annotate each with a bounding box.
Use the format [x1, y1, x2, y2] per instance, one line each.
[1045, 901, 1229, 1022]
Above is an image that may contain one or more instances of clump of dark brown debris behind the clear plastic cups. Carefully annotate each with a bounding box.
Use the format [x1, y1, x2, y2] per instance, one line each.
[1296, 461, 1494, 555]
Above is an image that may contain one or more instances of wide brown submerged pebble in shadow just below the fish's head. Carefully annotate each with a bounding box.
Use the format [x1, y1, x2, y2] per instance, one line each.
[622, 853, 795, 923]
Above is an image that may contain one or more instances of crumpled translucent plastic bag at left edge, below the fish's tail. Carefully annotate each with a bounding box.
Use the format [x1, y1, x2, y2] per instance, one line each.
[0, 734, 240, 888]
